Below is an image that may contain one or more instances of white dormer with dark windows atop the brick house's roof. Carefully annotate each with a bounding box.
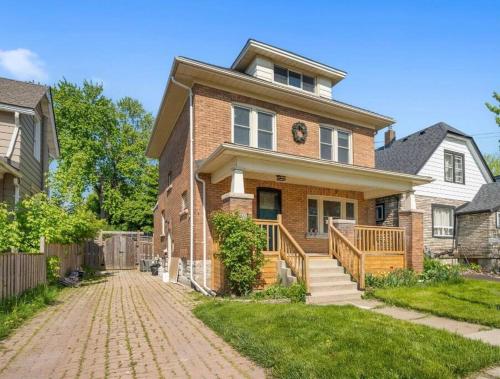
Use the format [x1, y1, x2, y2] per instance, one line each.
[231, 40, 345, 99]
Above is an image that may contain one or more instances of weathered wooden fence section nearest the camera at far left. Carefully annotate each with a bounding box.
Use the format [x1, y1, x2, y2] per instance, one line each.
[0, 253, 47, 299]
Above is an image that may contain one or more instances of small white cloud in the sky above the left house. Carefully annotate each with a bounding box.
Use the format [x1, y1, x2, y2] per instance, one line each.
[0, 48, 48, 81]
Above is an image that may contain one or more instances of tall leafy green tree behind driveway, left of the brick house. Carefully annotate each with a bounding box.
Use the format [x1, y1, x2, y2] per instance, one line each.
[51, 80, 158, 231]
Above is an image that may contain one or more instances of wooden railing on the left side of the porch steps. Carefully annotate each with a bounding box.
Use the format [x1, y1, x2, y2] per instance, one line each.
[254, 215, 309, 292]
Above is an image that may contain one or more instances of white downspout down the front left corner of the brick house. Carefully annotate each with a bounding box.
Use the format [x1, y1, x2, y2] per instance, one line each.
[170, 76, 212, 296]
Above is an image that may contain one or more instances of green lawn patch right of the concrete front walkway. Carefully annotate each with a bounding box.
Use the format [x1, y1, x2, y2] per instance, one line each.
[373, 279, 500, 328]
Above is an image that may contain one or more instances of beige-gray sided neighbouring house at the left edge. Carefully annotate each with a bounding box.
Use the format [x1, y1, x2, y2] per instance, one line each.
[0, 78, 59, 207]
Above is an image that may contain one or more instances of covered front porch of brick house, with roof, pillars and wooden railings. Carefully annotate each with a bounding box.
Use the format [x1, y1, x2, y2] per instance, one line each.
[199, 144, 430, 296]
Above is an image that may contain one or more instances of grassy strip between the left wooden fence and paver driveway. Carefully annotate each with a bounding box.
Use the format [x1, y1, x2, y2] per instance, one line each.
[0, 285, 62, 340]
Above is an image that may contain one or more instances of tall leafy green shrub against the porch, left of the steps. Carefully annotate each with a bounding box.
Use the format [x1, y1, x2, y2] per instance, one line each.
[211, 211, 266, 295]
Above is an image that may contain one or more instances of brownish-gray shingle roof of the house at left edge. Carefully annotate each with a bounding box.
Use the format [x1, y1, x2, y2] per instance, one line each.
[0, 78, 48, 109]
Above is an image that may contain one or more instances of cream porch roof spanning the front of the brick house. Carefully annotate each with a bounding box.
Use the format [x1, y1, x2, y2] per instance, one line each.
[198, 143, 433, 199]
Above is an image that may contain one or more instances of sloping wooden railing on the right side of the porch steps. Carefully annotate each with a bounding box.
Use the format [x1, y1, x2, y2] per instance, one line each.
[328, 219, 365, 290]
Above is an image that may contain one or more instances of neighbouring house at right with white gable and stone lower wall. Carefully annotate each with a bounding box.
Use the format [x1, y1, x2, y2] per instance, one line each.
[375, 122, 496, 268]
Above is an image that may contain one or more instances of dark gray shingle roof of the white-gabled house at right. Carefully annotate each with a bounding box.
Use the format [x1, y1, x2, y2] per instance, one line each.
[375, 122, 470, 175]
